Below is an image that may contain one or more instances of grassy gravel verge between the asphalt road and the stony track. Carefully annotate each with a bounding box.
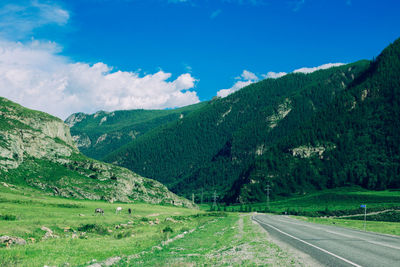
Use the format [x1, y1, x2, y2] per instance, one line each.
[117, 213, 301, 267]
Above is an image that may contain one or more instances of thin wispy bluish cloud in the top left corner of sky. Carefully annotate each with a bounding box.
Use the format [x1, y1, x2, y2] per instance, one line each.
[0, 0, 70, 40]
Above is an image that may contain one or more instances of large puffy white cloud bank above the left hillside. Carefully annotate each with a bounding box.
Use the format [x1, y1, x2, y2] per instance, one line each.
[0, 41, 199, 119]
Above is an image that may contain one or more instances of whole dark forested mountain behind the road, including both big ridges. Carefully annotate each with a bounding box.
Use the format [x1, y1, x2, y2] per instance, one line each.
[65, 37, 400, 202]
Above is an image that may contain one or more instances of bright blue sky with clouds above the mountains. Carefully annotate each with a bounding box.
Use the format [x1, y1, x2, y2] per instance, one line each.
[0, 0, 400, 117]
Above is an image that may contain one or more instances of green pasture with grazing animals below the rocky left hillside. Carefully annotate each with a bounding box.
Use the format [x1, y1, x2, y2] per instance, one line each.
[0, 185, 205, 266]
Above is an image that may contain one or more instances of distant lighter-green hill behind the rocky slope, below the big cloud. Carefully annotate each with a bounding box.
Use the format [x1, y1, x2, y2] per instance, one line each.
[65, 102, 206, 159]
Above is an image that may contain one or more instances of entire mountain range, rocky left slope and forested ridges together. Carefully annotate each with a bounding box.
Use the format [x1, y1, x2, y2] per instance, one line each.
[0, 40, 400, 206]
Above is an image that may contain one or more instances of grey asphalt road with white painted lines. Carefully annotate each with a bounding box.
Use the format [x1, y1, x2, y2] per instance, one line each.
[253, 215, 400, 267]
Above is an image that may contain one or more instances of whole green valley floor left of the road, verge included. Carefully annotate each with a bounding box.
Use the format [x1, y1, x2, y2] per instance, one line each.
[0, 184, 307, 267]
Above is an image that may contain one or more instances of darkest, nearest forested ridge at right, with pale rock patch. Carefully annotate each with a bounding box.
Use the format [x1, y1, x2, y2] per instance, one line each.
[226, 39, 400, 202]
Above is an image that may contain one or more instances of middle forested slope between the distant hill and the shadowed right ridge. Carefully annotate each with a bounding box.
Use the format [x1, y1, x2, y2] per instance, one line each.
[105, 61, 370, 199]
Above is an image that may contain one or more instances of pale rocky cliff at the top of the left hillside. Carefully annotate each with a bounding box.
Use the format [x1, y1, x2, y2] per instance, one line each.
[0, 98, 78, 171]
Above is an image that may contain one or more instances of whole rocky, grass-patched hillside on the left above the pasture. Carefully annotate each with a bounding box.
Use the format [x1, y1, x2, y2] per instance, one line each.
[0, 97, 193, 207]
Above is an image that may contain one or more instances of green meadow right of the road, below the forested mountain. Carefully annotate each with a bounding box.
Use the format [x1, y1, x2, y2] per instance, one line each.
[223, 187, 400, 238]
